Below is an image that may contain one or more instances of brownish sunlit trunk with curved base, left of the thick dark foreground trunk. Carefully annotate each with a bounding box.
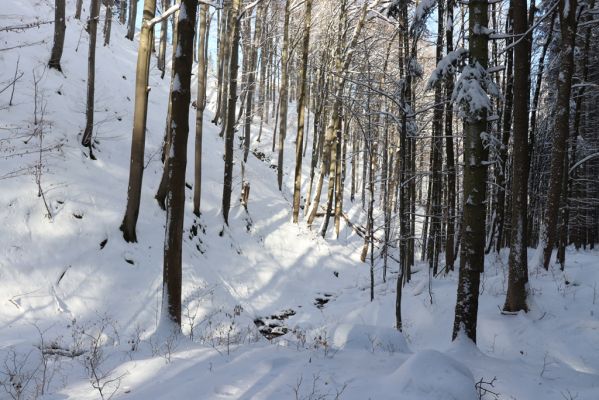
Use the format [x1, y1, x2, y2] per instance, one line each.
[121, 0, 156, 242]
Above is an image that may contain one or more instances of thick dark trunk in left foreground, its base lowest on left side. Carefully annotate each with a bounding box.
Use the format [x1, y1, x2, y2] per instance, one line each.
[162, 0, 198, 330]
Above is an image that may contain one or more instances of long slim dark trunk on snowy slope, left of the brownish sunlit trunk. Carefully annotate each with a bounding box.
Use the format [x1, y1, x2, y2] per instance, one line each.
[81, 0, 100, 160]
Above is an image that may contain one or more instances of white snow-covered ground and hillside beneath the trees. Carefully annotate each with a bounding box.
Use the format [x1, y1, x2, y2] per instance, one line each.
[0, 0, 599, 400]
